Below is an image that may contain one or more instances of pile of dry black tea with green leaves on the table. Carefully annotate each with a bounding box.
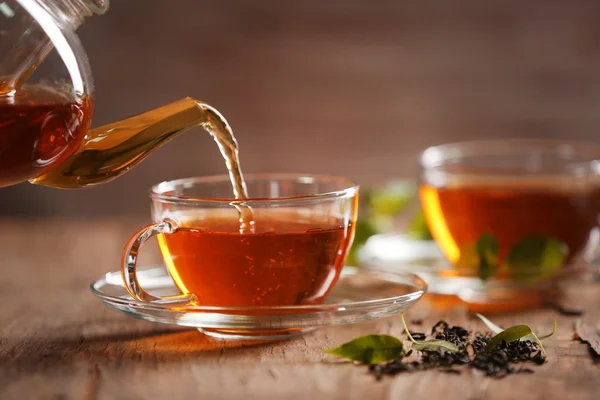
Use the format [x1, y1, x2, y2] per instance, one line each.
[326, 316, 556, 379]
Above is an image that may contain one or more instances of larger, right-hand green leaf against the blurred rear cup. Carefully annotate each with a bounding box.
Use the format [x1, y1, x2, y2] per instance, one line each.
[506, 235, 569, 278]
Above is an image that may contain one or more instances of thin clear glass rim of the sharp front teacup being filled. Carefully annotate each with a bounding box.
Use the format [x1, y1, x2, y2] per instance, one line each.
[149, 173, 359, 204]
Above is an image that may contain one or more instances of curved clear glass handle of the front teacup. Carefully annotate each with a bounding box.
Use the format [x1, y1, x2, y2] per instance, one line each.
[121, 218, 196, 304]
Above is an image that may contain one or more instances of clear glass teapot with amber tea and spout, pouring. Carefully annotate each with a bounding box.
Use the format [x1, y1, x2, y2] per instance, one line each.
[0, 0, 237, 189]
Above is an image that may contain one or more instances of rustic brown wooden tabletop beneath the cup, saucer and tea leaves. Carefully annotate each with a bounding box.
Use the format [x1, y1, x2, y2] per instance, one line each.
[0, 219, 600, 400]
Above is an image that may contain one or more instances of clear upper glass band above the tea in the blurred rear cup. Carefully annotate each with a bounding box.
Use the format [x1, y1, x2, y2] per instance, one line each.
[420, 138, 600, 186]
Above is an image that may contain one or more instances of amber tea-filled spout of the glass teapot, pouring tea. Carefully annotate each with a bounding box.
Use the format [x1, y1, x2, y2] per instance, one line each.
[30, 97, 238, 189]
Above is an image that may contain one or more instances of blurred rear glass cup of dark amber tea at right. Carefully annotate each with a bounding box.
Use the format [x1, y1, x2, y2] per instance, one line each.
[420, 139, 600, 302]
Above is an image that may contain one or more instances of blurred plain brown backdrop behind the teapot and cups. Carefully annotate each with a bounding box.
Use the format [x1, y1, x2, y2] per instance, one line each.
[0, 0, 600, 216]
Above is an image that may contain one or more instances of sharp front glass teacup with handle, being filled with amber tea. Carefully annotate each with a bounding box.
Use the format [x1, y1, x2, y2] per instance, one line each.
[122, 175, 358, 307]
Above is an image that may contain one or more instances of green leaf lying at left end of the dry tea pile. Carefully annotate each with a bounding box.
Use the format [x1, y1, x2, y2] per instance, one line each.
[323, 335, 404, 364]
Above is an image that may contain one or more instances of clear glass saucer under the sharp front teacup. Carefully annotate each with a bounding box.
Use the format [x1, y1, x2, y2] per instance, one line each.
[91, 267, 427, 340]
